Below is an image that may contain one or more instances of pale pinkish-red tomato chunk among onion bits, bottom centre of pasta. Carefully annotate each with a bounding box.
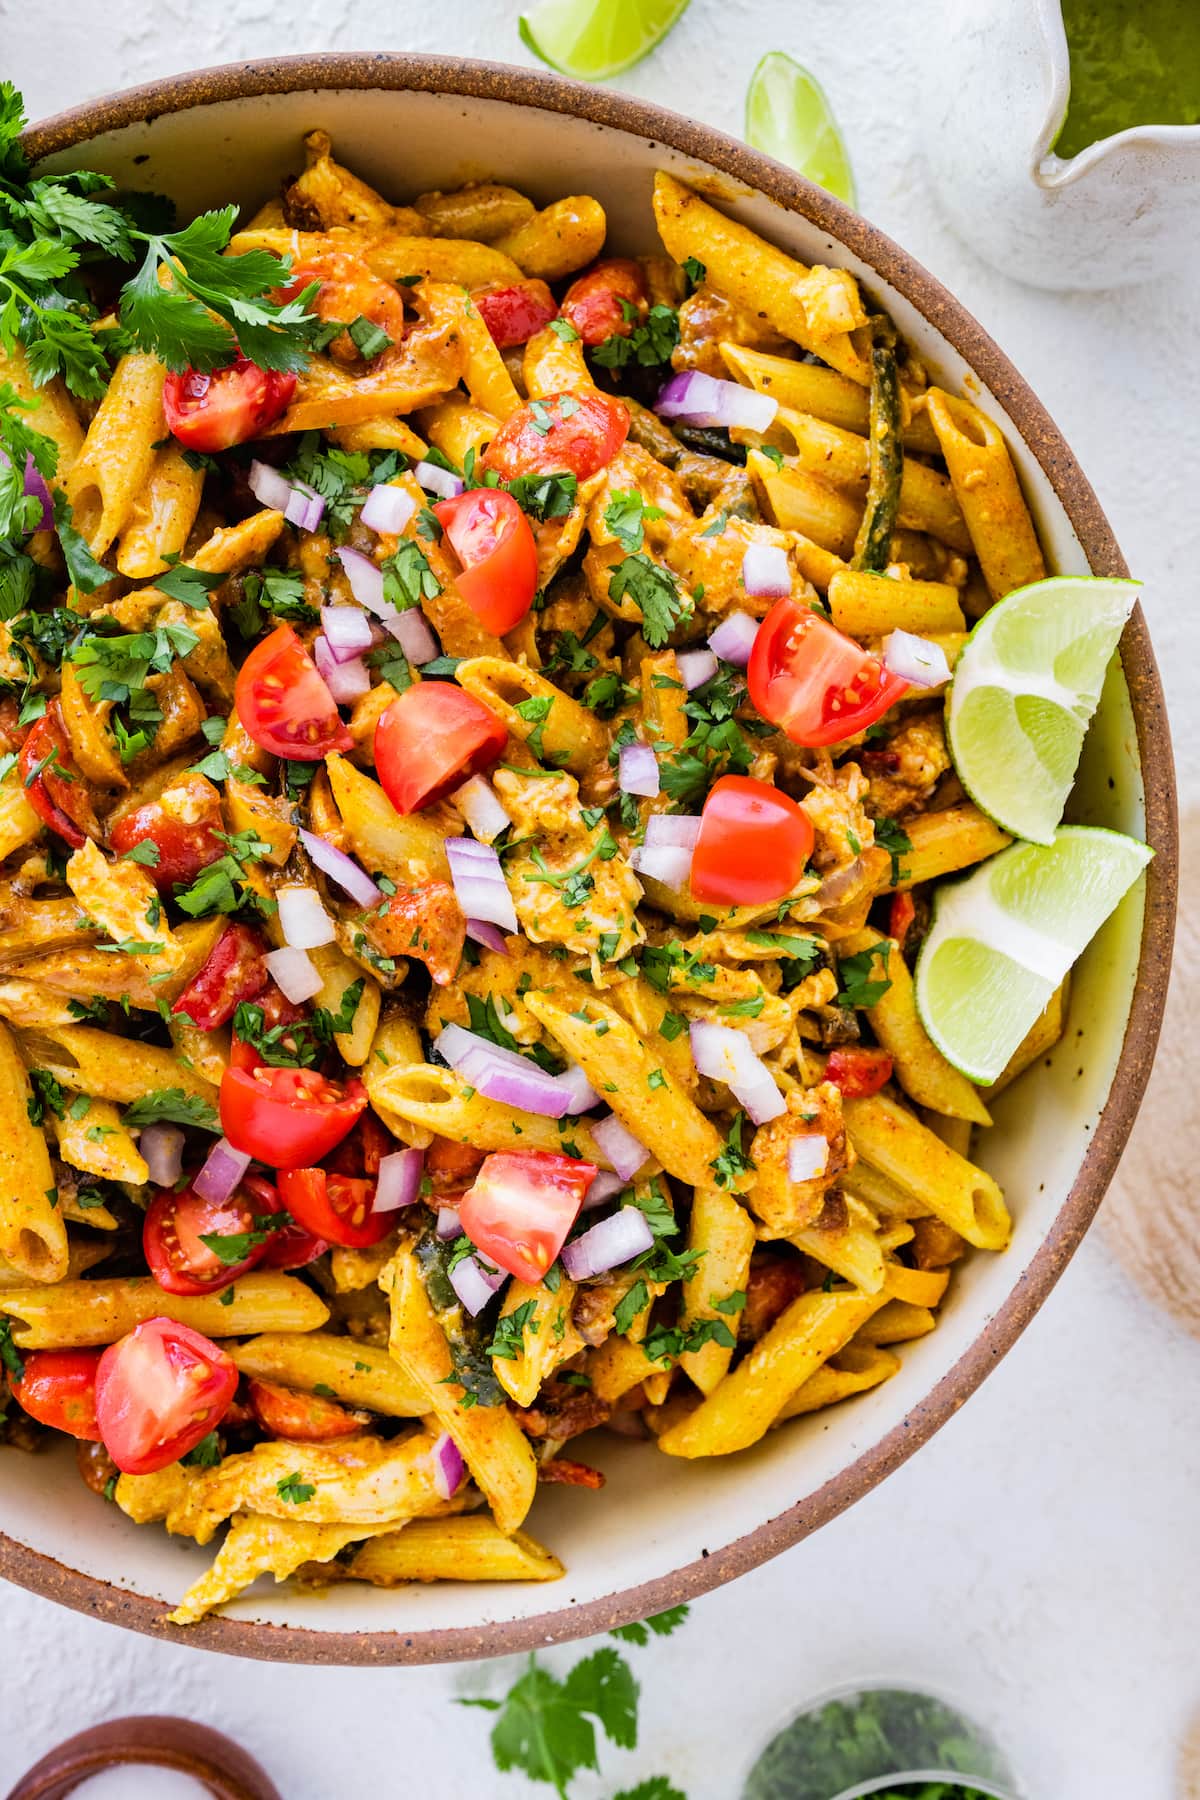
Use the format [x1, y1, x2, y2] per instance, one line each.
[459, 1150, 597, 1282]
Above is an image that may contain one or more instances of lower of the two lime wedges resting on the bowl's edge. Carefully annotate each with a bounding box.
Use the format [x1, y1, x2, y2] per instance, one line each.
[916, 824, 1153, 1082]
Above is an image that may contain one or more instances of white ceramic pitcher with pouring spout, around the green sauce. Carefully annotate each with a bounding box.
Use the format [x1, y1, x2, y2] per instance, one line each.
[923, 0, 1200, 288]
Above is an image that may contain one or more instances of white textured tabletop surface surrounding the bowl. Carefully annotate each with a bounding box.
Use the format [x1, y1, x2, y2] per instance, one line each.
[0, 0, 1200, 1800]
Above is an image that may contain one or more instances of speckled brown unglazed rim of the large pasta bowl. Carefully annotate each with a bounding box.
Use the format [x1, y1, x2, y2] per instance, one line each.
[0, 52, 1178, 1665]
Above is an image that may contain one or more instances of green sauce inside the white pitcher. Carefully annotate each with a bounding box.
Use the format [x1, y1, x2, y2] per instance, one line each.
[1054, 0, 1200, 157]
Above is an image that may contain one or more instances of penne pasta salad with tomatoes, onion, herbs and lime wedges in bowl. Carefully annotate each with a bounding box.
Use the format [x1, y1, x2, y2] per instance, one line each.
[0, 59, 1171, 1656]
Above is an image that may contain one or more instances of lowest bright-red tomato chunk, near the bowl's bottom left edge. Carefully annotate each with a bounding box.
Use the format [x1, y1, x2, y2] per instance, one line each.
[95, 1318, 237, 1474]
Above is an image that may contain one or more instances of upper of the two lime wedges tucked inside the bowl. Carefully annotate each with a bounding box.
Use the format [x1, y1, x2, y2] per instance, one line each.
[946, 574, 1141, 844]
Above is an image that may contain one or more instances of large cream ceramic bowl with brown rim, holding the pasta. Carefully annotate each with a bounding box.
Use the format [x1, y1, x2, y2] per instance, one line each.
[0, 56, 1177, 1663]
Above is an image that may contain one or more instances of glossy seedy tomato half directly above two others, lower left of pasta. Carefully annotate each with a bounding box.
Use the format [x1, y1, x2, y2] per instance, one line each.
[219, 1064, 367, 1166]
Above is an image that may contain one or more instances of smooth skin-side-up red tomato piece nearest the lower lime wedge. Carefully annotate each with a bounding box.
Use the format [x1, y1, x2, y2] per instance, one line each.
[691, 776, 813, 905]
